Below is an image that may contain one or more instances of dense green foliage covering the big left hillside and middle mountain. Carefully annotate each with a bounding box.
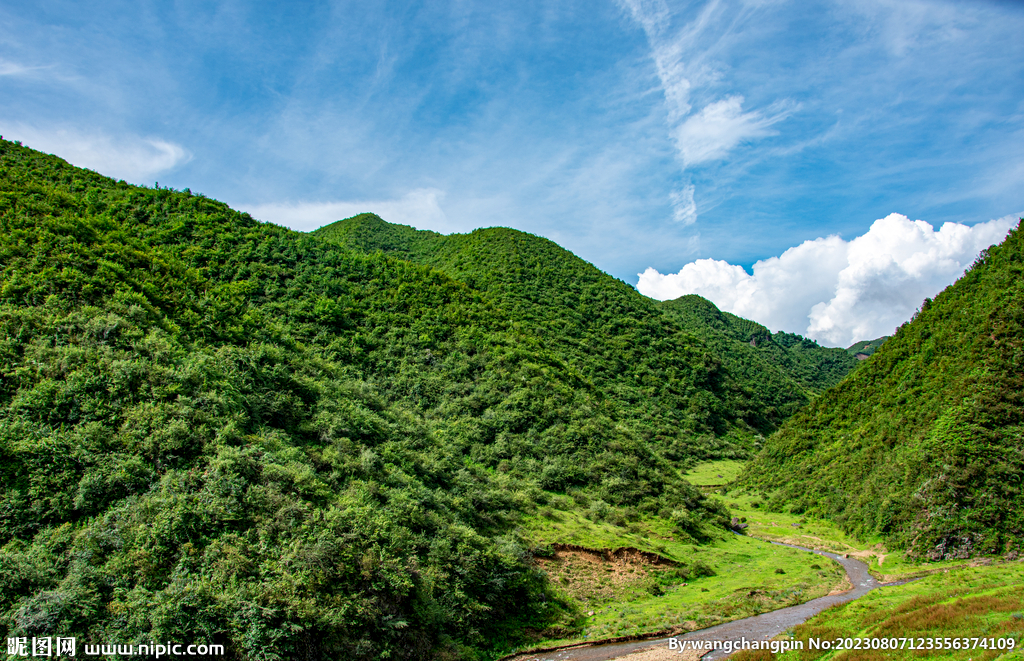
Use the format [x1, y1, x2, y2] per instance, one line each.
[0, 141, 790, 659]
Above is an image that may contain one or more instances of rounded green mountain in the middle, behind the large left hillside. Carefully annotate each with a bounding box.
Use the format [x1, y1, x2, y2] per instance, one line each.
[314, 214, 761, 464]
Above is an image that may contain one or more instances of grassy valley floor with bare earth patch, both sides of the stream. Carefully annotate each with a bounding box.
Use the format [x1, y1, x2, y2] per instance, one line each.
[503, 461, 1024, 661]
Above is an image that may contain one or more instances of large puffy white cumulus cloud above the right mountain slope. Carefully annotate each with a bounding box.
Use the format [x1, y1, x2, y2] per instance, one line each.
[637, 214, 1020, 347]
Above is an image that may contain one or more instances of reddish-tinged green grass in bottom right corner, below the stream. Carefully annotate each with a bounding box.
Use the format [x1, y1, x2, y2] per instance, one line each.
[765, 562, 1024, 661]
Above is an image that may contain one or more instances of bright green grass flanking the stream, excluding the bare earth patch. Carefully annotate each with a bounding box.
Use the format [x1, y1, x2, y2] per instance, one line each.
[525, 499, 1024, 661]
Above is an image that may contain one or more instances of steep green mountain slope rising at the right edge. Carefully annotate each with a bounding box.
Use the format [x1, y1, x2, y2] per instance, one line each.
[744, 221, 1024, 559]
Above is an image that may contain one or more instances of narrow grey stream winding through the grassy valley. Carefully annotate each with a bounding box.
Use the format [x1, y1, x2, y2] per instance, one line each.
[517, 542, 881, 661]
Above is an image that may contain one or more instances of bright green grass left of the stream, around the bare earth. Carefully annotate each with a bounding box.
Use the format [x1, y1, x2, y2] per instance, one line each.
[516, 508, 845, 646]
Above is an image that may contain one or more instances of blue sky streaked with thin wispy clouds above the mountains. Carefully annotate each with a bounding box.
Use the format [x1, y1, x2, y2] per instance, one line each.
[0, 0, 1024, 342]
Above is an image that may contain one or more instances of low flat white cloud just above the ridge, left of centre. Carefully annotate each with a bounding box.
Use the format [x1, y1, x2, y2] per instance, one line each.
[238, 188, 452, 232]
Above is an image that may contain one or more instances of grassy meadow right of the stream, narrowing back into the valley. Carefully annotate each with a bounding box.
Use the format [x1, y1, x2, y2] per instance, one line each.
[686, 461, 1024, 661]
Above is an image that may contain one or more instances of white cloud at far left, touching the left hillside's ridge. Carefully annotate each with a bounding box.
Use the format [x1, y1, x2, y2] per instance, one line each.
[0, 123, 191, 184]
